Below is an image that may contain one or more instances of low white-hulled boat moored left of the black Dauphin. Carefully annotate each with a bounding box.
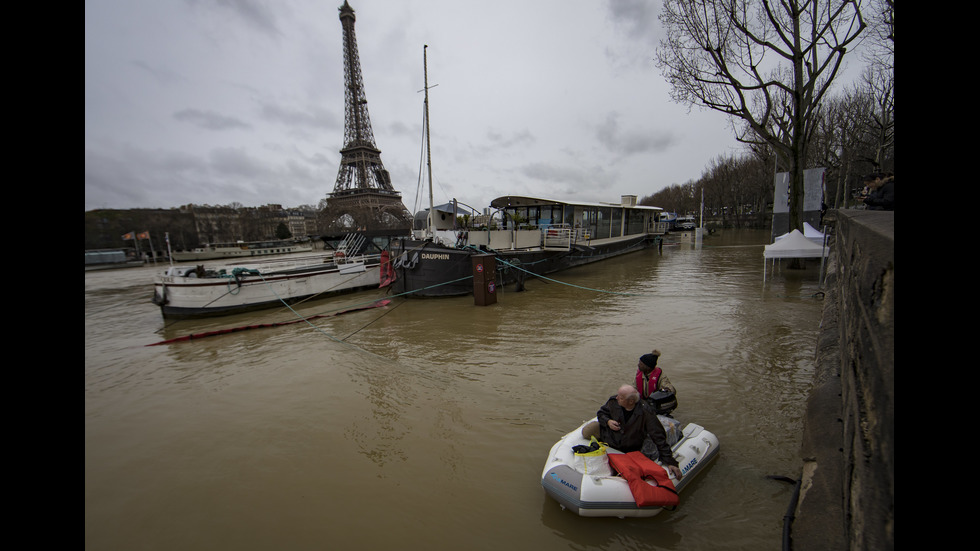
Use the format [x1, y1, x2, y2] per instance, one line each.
[153, 234, 385, 319]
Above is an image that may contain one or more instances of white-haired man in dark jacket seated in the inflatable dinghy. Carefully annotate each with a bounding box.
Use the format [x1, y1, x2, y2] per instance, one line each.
[596, 385, 683, 480]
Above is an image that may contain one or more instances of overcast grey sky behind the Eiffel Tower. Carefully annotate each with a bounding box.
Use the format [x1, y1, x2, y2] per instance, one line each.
[85, 0, 756, 212]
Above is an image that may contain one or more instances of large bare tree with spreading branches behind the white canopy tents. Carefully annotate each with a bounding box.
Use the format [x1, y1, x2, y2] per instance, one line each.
[657, 0, 866, 229]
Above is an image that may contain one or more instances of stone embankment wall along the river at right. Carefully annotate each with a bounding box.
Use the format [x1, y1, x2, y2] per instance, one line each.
[791, 210, 895, 551]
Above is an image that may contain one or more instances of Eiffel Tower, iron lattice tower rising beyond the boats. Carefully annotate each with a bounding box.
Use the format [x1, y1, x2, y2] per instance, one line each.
[320, 0, 412, 233]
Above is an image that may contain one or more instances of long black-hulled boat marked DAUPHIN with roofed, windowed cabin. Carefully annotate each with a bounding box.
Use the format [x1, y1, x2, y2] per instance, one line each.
[391, 195, 665, 297]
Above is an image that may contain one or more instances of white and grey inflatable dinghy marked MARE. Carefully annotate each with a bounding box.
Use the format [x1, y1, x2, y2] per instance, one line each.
[541, 418, 719, 518]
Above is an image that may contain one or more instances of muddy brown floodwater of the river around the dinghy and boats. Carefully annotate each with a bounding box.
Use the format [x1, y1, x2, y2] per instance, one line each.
[84, 230, 823, 551]
